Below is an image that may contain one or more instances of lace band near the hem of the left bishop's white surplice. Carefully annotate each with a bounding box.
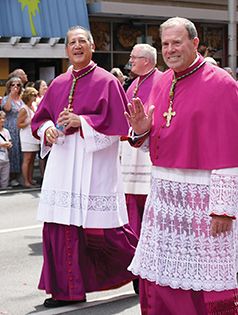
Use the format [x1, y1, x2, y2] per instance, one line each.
[41, 190, 125, 212]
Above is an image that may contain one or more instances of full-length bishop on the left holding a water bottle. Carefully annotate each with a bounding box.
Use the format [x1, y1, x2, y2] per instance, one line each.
[32, 27, 137, 307]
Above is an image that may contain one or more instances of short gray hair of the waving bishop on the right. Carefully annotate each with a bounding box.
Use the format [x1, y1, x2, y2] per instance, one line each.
[160, 16, 198, 39]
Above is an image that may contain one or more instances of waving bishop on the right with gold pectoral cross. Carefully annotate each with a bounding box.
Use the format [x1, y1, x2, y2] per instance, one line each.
[127, 18, 238, 315]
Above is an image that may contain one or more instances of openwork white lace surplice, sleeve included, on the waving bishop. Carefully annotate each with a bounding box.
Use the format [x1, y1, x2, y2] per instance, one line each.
[129, 167, 238, 291]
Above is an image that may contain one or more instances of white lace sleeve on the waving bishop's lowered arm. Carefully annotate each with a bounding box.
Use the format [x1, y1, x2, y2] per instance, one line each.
[209, 174, 238, 216]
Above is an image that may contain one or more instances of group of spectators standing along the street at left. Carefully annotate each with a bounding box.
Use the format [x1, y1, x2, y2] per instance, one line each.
[0, 69, 48, 189]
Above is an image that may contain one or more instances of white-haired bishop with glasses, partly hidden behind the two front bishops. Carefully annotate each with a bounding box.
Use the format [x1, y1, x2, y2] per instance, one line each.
[121, 44, 162, 237]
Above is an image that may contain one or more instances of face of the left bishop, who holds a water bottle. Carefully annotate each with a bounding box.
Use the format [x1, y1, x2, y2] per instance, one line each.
[66, 29, 95, 69]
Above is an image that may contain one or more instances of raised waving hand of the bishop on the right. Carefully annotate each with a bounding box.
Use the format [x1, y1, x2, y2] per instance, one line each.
[124, 97, 154, 135]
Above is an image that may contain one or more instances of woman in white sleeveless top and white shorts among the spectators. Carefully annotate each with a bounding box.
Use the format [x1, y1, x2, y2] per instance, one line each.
[17, 87, 39, 188]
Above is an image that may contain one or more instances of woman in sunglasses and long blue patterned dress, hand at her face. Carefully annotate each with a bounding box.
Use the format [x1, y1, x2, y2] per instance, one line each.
[1, 77, 24, 187]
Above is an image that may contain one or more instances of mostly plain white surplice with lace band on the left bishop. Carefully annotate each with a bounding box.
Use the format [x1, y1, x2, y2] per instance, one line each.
[38, 117, 128, 228]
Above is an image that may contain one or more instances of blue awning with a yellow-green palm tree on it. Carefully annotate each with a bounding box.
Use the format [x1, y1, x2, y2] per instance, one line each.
[0, 0, 89, 38]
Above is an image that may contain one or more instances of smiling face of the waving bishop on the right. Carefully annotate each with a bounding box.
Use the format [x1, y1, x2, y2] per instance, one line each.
[161, 25, 199, 72]
